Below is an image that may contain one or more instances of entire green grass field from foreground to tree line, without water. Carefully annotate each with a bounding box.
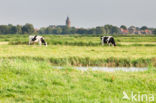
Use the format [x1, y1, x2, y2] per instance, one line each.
[0, 35, 156, 103]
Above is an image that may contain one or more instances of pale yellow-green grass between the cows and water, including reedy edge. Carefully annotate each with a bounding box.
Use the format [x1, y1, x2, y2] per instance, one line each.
[0, 45, 156, 67]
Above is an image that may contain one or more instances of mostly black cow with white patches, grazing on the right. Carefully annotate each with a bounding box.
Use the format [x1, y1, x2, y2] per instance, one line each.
[101, 36, 116, 46]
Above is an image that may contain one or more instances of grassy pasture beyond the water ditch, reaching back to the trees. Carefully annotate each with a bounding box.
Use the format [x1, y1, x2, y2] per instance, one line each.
[0, 35, 156, 67]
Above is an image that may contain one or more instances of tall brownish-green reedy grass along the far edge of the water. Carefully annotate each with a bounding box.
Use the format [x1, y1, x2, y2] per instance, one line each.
[0, 56, 156, 67]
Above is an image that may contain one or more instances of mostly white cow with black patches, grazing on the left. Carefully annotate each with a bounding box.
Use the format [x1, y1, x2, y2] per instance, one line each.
[29, 35, 47, 46]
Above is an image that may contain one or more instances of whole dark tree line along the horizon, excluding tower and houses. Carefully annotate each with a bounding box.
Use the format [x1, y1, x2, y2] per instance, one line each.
[0, 23, 156, 35]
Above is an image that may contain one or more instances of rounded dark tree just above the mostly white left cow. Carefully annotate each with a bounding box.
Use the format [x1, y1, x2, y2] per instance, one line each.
[22, 23, 35, 34]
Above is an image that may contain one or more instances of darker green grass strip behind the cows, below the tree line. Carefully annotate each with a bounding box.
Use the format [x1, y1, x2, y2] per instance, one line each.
[0, 35, 156, 46]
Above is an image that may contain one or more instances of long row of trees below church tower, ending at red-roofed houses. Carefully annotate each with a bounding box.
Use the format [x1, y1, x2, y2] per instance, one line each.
[38, 25, 120, 34]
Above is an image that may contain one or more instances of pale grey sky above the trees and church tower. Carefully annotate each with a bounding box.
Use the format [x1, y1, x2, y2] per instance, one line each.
[0, 0, 156, 28]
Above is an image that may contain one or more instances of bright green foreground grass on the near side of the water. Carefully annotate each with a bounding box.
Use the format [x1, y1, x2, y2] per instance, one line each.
[0, 59, 156, 103]
